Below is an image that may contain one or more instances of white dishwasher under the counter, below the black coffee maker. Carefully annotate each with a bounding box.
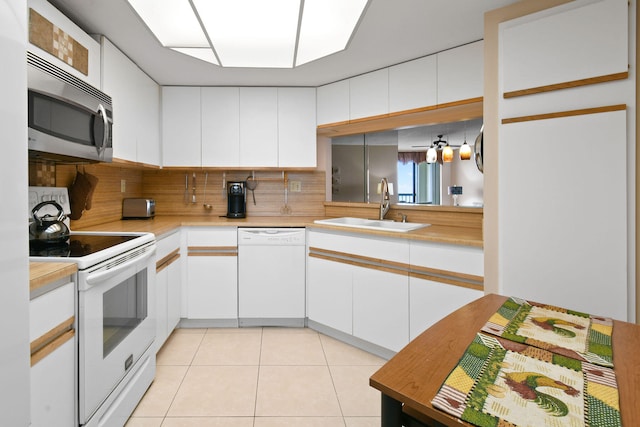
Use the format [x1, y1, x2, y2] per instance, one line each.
[238, 228, 306, 327]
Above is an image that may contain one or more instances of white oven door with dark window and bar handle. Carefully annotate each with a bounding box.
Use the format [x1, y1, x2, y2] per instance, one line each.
[78, 243, 156, 424]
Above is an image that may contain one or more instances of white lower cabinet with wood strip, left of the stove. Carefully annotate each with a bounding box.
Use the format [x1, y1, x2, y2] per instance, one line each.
[29, 279, 78, 427]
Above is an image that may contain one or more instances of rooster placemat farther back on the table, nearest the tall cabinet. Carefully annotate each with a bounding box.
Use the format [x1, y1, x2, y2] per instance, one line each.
[482, 297, 613, 367]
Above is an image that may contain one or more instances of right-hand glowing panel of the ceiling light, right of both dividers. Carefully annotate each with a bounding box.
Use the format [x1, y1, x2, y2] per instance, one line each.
[295, 0, 368, 66]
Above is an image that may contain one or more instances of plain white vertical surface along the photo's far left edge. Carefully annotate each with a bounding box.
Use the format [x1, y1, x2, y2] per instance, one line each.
[0, 0, 30, 427]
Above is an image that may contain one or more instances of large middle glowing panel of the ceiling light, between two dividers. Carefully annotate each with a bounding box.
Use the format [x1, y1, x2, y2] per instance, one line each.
[193, 0, 300, 68]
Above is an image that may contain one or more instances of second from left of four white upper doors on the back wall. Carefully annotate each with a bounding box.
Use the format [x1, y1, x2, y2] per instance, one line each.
[201, 87, 240, 167]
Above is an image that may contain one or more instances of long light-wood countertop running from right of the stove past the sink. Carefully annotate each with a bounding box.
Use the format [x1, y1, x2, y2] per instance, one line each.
[76, 216, 483, 248]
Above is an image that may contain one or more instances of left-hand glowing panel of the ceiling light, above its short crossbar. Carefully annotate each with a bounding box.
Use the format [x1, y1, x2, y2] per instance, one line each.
[128, 0, 209, 48]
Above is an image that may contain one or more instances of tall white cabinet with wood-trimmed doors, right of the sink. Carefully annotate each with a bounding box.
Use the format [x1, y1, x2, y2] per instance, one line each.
[498, 0, 636, 321]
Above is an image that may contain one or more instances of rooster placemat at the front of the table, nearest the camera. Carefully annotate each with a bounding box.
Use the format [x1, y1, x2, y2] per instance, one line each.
[431, 333, 622, 427]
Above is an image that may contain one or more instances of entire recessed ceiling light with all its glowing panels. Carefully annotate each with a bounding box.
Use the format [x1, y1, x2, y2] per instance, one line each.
[127, 0, 370, 68]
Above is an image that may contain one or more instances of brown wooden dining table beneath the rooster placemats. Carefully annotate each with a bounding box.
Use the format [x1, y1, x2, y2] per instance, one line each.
[369, 294, 640, 427]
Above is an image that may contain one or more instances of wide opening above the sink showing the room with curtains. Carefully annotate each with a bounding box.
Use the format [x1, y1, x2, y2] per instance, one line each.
[331, 119, 483, 207]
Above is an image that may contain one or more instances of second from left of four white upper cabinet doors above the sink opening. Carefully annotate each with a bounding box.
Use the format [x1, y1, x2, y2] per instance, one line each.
[349, 68, 389, 120]
